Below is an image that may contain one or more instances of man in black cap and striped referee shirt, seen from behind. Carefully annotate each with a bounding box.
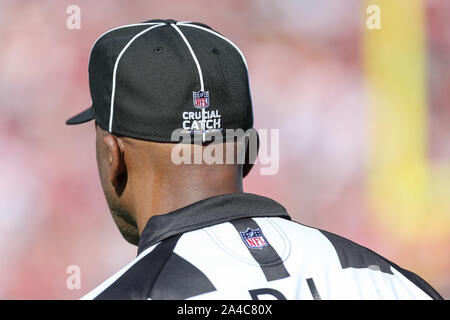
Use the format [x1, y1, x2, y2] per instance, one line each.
[67, 20, 441, 299]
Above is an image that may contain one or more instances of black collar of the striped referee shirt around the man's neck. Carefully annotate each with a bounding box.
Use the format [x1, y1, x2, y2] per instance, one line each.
[138, 193, 291, 255]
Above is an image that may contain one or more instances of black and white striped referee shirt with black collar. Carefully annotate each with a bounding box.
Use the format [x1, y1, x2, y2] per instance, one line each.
[82, 193, 442, 299]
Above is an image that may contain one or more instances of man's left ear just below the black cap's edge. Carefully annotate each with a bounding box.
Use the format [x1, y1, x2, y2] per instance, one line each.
[103, 134, 127, 195]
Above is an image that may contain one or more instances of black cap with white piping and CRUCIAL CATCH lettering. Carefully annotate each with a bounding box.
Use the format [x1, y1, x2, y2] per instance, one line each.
[66, 19, 253, 176]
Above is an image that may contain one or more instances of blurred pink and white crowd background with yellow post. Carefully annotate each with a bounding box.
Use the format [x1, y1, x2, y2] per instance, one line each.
[0, 0, 450, 299]
